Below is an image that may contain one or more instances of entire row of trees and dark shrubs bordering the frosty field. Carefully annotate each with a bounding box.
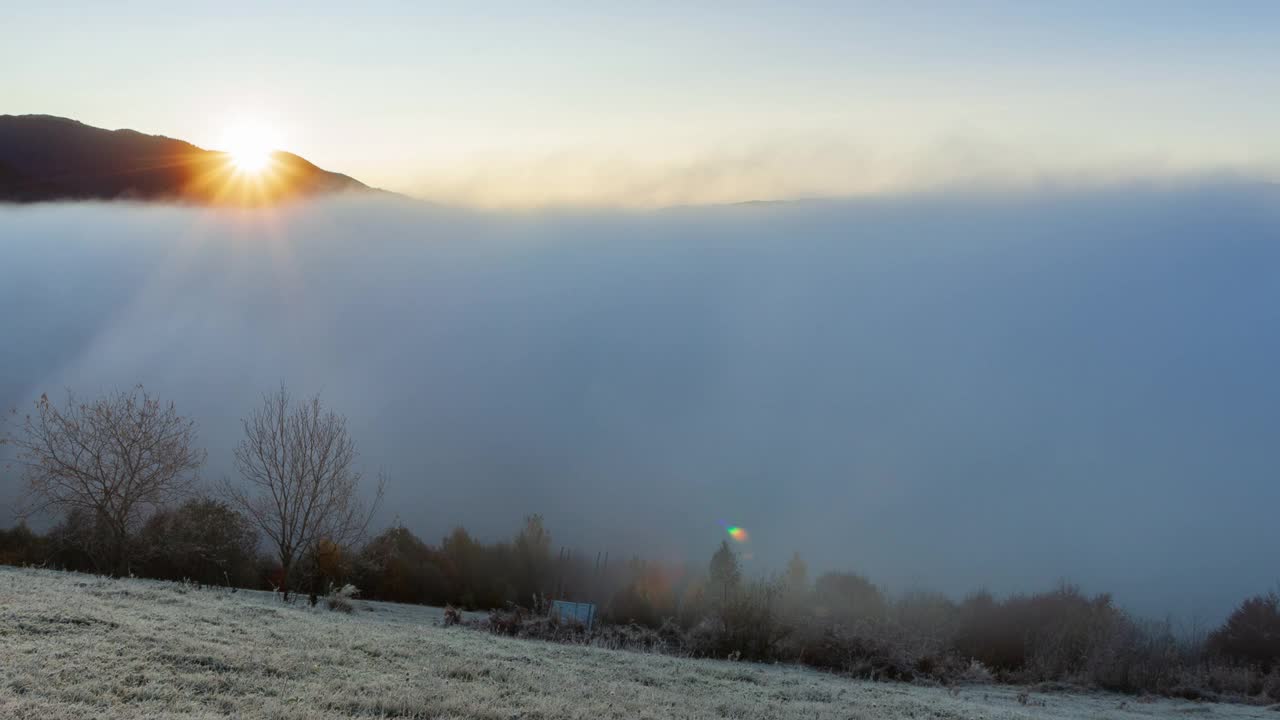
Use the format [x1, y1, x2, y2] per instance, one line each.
[0, 387, 1280, 701]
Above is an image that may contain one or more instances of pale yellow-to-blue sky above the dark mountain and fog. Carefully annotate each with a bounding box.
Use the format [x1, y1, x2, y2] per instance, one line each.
[0, 0, 1280, 208]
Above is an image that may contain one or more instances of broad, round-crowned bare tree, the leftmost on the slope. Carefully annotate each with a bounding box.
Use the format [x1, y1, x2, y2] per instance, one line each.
[9, 386, 205, 574]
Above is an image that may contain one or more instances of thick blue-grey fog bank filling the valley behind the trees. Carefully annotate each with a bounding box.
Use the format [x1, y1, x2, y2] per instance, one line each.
[0, 183, 1280, 620]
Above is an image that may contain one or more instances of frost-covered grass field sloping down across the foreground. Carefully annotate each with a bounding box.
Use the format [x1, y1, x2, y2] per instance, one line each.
[0, 568, 1277, 720]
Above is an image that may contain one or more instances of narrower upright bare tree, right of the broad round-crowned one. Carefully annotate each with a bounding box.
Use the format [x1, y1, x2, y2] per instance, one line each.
[223, 386, 383, 594]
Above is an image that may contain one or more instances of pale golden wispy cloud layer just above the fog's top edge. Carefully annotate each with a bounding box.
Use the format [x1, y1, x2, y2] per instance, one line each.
[404, 132, 1280, 210]
